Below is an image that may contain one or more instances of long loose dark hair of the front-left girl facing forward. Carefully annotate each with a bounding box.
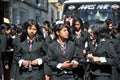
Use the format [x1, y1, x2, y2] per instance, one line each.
[20, 19, 43, 42]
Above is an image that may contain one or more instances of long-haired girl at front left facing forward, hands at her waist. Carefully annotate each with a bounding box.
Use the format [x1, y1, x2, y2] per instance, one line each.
[14, 19, 46, 80]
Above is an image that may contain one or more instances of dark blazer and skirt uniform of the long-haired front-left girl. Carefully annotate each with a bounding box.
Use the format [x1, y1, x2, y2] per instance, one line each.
[14, 39, 46, 80]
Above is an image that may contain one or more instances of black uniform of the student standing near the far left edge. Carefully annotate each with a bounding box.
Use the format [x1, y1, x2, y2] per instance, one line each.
[2, 35, 13, 80]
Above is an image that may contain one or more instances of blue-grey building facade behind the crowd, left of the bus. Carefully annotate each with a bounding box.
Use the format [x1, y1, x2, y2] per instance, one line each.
[0, 0, 59, 24]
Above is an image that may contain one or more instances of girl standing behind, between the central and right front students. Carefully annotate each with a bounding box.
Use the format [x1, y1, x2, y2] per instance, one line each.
[71, 19, 90, 80]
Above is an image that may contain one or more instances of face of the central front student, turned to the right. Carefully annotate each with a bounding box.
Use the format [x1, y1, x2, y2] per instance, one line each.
[57, 27, 69, 40]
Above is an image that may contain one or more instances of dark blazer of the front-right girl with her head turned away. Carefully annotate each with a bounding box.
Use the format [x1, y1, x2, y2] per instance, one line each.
[88, 40, 117, 76]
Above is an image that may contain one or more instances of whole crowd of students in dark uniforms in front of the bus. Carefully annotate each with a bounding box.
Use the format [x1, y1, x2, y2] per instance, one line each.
[0, 19, 120, 80]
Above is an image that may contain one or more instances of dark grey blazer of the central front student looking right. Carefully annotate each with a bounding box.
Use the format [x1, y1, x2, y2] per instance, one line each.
[48, 41, 83, 75]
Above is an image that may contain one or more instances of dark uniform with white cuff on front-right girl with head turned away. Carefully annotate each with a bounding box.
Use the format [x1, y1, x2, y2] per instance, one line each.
[87, 39, 117, 80]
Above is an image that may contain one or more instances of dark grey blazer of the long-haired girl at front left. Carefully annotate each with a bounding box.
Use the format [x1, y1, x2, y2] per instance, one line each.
[14, 40, 46, 69]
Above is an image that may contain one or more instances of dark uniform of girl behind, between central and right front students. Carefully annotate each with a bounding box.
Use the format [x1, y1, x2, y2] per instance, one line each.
[72, 30, 90, 80]
